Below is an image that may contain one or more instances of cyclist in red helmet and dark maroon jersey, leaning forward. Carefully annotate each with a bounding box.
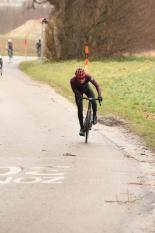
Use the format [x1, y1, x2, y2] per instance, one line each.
[70, 68, 103, 136]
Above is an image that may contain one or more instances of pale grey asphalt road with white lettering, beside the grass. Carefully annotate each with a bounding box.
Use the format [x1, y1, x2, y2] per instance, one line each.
[0, 57, 151, 233]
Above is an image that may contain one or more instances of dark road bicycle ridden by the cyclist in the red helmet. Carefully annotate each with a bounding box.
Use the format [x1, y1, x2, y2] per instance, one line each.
[82, 97, 101, 143]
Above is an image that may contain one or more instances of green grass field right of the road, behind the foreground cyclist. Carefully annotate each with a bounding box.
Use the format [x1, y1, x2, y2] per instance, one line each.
[21, 57, 155, 148]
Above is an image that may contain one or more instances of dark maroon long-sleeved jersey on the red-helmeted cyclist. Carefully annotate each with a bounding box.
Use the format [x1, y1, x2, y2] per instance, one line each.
[70, 74, 101, 96]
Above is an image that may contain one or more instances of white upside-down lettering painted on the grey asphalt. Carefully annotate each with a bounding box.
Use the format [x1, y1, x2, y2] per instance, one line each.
[0, 166, 69, 184]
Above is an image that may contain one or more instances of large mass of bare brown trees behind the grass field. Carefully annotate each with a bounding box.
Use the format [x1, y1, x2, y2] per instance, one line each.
[32, 0, 155, 59]
